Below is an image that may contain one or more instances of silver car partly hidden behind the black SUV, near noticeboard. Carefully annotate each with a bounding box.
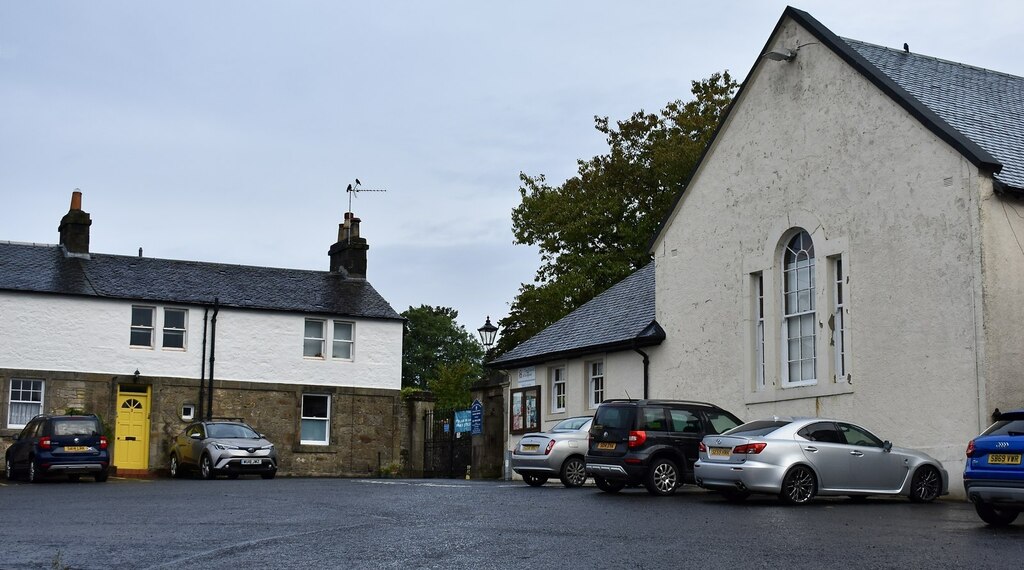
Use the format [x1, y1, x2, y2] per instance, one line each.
[512, 415, 593, 487]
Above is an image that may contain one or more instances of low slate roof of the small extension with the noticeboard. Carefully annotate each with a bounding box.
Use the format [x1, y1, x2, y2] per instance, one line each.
[487, 262, 665, 368]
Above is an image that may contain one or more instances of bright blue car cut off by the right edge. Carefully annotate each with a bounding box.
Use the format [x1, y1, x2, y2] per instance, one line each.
[964, 409, 1024, 526]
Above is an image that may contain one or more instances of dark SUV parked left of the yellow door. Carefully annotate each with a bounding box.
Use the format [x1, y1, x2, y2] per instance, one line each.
[4, 415, 111, 483]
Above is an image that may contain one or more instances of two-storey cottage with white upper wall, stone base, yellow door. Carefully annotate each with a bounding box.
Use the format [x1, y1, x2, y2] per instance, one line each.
[0, 192, 404, 475]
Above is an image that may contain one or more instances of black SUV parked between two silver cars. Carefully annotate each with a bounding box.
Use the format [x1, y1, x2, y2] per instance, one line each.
[587, 400, 742, 495]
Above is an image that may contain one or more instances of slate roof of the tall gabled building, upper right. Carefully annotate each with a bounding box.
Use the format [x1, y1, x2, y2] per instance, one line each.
[843, 38, 1024, 190]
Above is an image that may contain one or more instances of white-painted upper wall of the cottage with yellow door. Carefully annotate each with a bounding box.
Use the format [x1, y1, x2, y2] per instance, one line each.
[0, 292, 402, 390]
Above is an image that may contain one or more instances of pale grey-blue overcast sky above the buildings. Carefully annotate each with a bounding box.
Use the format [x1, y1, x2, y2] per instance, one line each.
[0, 0, 1024, 336]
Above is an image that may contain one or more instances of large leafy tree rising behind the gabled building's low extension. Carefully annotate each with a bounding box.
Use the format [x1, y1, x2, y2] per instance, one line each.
[496, 71, 738, 353]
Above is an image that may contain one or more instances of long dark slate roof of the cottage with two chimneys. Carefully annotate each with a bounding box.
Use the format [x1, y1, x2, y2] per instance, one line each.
[0, 242, 401, 319]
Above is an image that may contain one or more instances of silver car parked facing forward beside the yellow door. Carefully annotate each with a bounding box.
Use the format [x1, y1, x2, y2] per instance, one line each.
[170, 421, 278, 479]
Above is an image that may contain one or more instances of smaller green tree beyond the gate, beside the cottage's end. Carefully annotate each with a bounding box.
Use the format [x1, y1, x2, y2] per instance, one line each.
[401, 305, 483, 408]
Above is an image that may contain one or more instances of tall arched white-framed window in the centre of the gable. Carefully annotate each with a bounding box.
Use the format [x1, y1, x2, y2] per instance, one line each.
[781, 230, 817, 386]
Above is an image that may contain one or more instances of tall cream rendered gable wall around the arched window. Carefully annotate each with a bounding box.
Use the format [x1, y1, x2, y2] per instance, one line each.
[651, 16, 987, 493]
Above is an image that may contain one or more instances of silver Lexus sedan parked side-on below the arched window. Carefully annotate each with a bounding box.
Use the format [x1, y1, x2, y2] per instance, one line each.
[693, 418, 949, 505]
